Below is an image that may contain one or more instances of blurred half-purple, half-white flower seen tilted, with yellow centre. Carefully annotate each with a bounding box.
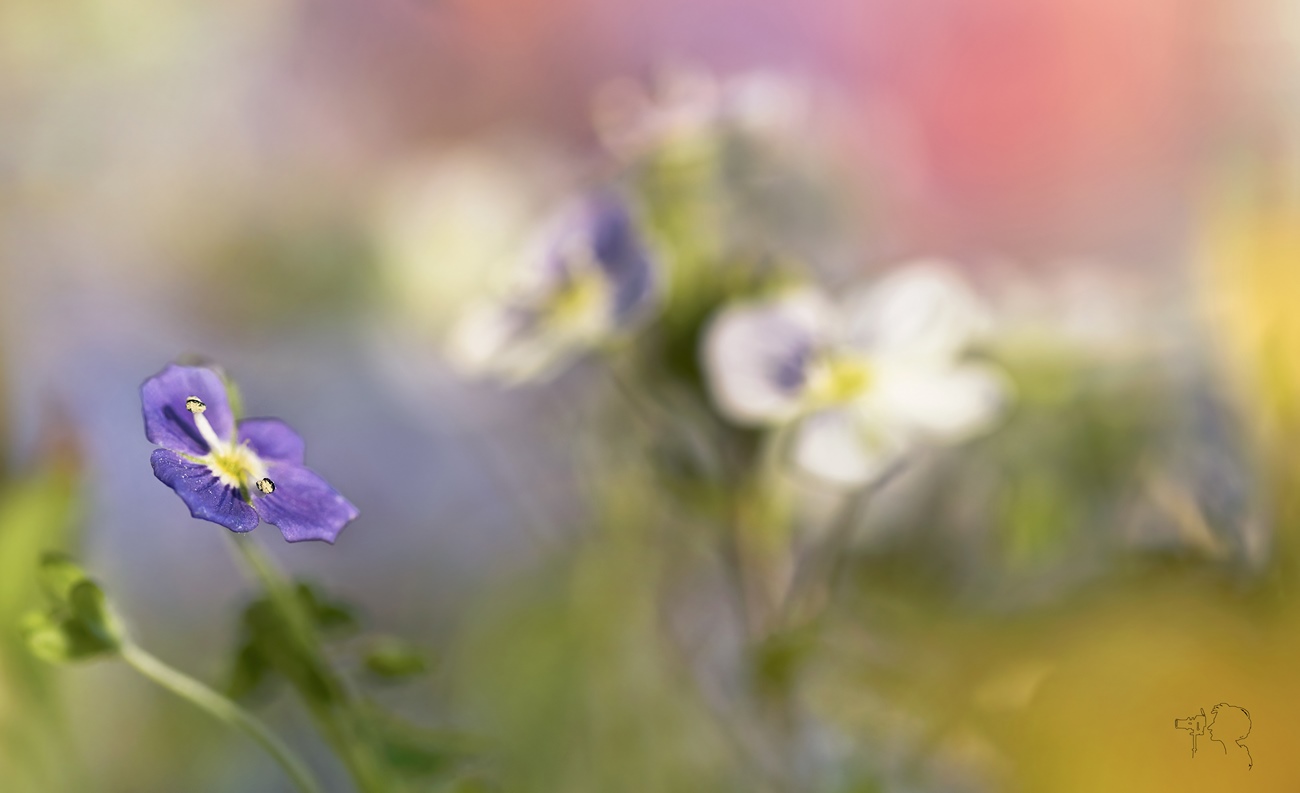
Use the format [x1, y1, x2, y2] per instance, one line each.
[450, 194, 662, 382]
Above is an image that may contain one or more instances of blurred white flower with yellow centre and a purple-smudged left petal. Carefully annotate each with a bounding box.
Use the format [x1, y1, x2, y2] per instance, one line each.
[703, 261, 1010, 485]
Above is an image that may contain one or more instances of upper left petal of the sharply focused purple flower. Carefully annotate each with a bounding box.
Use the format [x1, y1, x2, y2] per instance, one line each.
[140, 364, 235, 455]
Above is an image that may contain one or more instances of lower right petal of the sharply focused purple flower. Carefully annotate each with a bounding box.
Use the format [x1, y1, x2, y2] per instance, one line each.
[254, 463, 358, 542]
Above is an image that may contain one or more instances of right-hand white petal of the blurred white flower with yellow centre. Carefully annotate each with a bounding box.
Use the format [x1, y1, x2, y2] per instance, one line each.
[866, 364, 1011, 442]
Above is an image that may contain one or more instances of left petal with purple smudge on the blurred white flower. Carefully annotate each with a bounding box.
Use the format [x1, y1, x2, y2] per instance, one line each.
[702, 290, 831, 424]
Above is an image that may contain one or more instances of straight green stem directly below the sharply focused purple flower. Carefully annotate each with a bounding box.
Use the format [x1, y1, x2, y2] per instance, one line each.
[231, 536, 400, 793]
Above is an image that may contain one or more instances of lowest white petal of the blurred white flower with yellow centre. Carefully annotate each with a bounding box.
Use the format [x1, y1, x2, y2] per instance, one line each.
[793, 407, 904, 486]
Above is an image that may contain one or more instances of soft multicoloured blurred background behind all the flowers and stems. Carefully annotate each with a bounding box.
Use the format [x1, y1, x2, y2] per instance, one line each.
[0, 0, 1300, 793]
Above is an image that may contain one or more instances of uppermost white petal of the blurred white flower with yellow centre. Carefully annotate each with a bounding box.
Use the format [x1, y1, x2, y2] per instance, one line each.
[845, 260, 989, 361]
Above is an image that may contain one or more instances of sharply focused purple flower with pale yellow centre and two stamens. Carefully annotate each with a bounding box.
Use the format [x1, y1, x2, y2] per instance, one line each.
[140, 364, 358, 542]
